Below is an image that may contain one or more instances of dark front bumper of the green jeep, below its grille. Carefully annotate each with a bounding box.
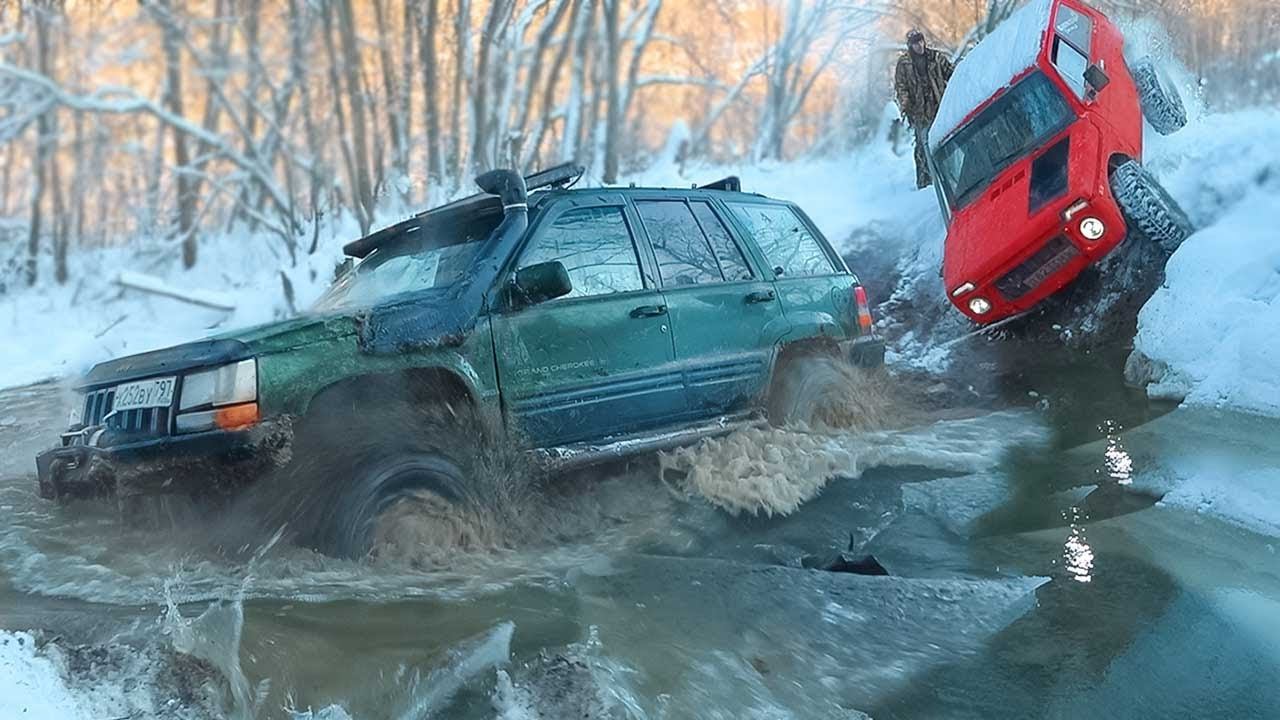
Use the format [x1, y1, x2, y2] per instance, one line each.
[36, 419, 293, 500]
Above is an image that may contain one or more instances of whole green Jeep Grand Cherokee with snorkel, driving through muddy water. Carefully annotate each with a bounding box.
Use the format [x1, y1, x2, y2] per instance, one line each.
[37, 165, 883, 555]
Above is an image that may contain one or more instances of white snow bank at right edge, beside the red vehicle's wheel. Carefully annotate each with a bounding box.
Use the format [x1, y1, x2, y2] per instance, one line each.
[1130, 110, 1280, 415]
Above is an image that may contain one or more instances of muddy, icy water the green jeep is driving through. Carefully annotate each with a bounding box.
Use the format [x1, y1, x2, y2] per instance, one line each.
[0, 364, 1280, 719]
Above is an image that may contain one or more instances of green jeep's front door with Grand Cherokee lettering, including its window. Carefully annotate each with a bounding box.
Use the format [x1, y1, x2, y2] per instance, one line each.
[492, 193, 685, 447]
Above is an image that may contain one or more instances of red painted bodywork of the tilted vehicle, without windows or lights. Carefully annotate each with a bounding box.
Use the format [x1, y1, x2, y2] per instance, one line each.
[942, 0, 1142, 323]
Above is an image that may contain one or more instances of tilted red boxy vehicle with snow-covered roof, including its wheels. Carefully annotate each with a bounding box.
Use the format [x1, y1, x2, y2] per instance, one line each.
[928, 0, 1192, 324]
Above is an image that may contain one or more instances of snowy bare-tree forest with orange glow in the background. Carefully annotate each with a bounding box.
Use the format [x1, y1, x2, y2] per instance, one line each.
[0, 0, 1280, 284]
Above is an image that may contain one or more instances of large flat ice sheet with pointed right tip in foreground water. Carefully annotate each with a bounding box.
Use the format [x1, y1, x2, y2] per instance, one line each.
[577, 548, 1047, 717]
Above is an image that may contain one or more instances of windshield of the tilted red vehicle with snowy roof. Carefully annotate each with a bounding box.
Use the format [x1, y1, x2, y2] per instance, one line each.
[933, 70, 1074, 210]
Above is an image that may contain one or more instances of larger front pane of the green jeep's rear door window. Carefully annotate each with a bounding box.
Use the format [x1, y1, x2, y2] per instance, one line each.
[636, 200, 723, 287]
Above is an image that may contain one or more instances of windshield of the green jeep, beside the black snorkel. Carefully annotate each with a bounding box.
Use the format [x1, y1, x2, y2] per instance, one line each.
[315, 210, 500, 311]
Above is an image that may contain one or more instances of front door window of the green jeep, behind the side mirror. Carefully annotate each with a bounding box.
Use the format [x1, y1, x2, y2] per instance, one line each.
[518, 206, 644, 297]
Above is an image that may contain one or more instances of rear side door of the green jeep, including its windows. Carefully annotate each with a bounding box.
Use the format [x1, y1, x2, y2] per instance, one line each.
[632, 195, 782, 419]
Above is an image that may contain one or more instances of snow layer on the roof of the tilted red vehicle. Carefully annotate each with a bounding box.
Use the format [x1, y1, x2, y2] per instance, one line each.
[929, 0, 1053, 147]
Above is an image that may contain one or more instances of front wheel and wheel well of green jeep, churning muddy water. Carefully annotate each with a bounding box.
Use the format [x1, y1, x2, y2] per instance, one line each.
[278, 398, 484, 561]
